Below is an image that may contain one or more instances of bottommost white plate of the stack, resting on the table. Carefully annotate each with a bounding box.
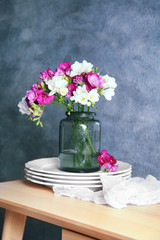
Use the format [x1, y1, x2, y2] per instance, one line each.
[25, 176, 102, 191]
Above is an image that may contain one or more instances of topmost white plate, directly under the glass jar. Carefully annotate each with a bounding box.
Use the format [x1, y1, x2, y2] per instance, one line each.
[25, 158, 132, 177]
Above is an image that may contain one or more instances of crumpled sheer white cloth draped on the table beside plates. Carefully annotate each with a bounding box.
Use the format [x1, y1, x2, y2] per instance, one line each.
[53, 173, 160, 209]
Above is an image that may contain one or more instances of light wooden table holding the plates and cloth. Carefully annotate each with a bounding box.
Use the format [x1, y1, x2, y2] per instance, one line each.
[0, 180, 160, 240]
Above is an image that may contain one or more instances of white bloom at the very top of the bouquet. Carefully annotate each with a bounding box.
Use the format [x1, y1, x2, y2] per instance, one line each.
[70, 60, 93, 77]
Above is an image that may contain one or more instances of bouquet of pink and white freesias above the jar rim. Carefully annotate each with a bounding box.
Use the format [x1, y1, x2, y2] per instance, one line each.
[18, 60, 117, 172]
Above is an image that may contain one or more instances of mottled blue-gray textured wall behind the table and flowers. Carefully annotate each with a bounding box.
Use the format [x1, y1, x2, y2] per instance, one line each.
[0, 0, 160, 240]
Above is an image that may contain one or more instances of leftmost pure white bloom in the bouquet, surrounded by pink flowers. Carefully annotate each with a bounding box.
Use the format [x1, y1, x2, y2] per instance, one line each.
[46, 76, 68, 96]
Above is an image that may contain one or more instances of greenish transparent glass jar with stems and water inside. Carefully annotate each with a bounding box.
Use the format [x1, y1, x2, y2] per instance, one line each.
[59, 112, 101, 173]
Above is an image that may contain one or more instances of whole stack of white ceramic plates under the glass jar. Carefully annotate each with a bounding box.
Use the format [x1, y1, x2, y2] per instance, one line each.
[24, 158, 132, 191]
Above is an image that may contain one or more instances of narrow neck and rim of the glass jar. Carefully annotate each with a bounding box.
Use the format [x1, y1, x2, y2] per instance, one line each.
[66, 112, 96, 120]
